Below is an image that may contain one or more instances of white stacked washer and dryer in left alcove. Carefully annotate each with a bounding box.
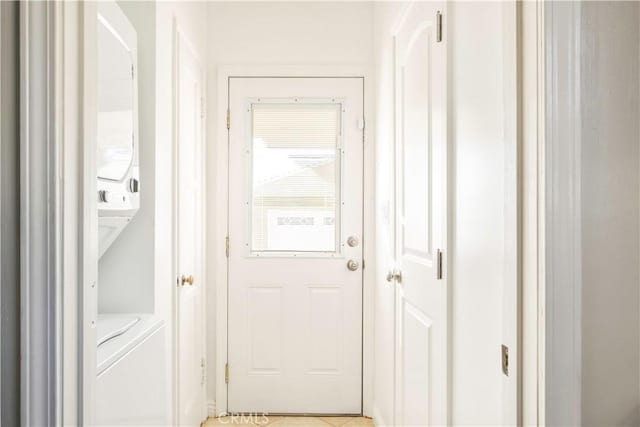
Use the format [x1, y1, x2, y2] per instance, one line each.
[95, 1, 167, 426]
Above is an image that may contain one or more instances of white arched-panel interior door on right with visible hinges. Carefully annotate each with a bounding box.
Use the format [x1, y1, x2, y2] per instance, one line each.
[395, 2, 449, 426]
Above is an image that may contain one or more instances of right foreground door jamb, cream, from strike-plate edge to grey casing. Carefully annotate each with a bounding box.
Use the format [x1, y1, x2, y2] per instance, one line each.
[502, 0, 548, 425]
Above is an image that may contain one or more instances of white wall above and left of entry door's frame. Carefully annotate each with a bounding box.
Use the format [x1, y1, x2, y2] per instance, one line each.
[207, 2, 373, 412]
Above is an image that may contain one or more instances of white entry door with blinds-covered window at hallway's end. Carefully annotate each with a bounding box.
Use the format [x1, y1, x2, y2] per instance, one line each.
[228, 78, 364, 414]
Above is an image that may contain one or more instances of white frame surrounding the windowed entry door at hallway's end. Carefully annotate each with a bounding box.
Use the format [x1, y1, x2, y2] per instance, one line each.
[215, 65, 375, 416]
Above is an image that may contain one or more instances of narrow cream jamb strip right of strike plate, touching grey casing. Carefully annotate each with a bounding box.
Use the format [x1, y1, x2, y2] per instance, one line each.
[517, 0, 547, 425]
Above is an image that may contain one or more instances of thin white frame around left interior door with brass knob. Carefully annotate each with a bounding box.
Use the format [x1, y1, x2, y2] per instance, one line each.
[171, 21, 207, 425]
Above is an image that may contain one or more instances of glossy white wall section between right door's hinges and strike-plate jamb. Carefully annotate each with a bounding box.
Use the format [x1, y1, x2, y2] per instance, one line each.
[447, 2, 505, 425]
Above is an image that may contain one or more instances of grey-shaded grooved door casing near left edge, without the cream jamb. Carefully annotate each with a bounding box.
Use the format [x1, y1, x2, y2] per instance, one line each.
[20, 2, 62, 425]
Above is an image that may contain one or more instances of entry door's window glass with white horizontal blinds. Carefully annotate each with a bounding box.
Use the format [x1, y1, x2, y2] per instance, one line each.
[250, 103, 341, 252]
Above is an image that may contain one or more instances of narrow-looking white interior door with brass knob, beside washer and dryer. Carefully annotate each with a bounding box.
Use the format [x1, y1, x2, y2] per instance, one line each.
[175, 33, 205, 426]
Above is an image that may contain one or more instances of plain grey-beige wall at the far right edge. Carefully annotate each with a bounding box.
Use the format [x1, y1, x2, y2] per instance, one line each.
[580, 2, 640, 426]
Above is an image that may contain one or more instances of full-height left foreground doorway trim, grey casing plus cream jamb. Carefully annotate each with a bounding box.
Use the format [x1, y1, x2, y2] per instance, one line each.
[19, 2, 90, 425]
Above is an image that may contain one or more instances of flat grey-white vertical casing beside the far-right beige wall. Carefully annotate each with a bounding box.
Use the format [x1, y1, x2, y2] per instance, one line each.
[541, 2, 582, 426]
